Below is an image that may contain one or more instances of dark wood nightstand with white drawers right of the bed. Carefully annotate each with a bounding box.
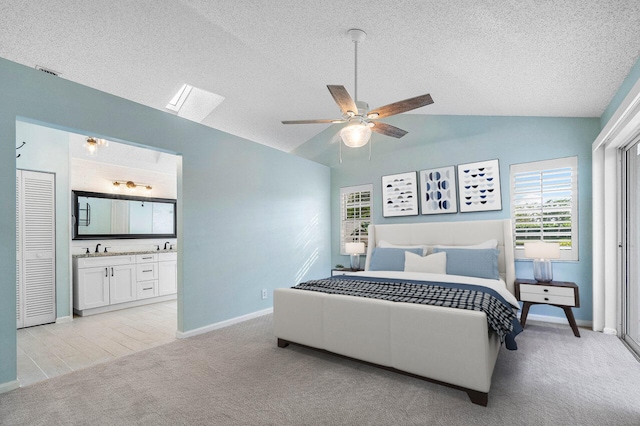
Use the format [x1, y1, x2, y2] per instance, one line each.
[515, 279, 580, 337]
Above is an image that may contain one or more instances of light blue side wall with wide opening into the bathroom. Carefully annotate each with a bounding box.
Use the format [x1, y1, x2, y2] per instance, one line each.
[0, 59, 331, 386]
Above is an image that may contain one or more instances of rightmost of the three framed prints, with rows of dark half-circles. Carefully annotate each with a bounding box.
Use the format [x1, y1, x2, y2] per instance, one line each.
[458, 160, 502, 213]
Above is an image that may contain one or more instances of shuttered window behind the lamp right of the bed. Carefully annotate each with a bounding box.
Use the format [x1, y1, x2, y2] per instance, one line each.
[511, 157, 578, 260]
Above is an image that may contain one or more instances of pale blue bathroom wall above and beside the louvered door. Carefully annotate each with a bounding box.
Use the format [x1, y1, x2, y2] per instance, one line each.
[16, 121, 72, 318]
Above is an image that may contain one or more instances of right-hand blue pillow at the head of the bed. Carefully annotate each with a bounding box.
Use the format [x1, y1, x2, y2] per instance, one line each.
[433, 247, 500, 280]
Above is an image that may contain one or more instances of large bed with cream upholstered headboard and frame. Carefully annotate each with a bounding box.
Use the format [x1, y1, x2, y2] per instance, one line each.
[273, 220, 518, 406]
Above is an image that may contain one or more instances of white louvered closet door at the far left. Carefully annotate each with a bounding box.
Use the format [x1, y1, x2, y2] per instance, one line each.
[17, 170, 56, 327]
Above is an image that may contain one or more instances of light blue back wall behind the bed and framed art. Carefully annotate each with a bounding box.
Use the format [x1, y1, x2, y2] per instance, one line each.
[295, 114, 600, 320]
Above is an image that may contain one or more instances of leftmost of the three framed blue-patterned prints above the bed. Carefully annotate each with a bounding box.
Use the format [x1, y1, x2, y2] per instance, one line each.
[382, 172, 418, 217]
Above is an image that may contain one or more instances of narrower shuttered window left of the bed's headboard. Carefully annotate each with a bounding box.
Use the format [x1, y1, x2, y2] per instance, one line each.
[340, 184, 373, 254]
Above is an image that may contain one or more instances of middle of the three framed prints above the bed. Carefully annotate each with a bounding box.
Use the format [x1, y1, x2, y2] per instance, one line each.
[420, 166, 458, 214]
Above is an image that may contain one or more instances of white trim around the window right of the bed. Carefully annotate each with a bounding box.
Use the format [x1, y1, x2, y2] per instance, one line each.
[509, 156, 579, 261]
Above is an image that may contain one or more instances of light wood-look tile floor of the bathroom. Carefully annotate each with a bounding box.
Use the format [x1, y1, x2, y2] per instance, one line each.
[18, 300, 177, 386]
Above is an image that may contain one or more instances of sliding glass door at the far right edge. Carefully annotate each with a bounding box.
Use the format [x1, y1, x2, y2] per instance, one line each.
[622, 139, 640, 355]
